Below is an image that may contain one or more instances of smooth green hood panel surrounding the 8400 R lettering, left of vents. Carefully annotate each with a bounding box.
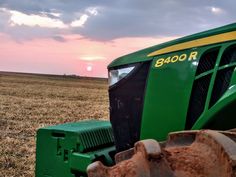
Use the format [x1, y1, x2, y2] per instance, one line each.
[141, 47, 208, 140]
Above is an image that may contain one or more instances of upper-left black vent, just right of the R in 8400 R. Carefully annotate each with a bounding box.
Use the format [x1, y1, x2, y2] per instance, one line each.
[196, 47, 219, 75]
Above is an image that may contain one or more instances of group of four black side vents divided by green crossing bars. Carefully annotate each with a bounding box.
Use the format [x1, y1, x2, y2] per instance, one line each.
[185, 44, 236, 129]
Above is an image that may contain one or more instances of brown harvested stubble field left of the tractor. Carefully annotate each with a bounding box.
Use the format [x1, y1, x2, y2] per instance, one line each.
[0, 72, 108, 177]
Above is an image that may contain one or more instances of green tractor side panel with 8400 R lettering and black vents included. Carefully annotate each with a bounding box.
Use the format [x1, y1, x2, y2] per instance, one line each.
[141, 41, 236, 140]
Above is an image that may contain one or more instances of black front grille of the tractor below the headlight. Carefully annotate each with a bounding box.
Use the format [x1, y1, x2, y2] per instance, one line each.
[109, 62, 150, 152]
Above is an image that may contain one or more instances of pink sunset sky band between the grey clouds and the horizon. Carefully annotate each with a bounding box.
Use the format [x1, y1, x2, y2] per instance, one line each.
[0, 34, 177, 77]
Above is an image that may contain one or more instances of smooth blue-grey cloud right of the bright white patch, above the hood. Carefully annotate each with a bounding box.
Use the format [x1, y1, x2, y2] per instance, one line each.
[68, 0, 236, 41]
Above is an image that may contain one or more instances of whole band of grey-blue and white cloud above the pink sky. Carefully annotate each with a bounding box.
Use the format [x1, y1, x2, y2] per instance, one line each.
[0, 0, 236, 41]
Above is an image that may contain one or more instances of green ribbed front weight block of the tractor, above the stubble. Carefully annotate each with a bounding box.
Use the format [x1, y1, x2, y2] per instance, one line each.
[35, 120, 115, 177]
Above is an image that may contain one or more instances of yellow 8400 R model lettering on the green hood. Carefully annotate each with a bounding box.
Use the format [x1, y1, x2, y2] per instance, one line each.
[155, 51, 198, 68]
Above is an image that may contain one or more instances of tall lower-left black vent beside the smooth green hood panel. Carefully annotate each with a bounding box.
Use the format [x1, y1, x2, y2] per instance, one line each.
[186, 74, 211, 129]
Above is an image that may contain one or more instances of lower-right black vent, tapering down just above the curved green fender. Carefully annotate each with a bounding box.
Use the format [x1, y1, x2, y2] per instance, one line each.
[210, 67, 234, 107]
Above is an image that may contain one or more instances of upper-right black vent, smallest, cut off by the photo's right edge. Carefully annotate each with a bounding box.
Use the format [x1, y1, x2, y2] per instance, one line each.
[220, 45, 236, 66]
